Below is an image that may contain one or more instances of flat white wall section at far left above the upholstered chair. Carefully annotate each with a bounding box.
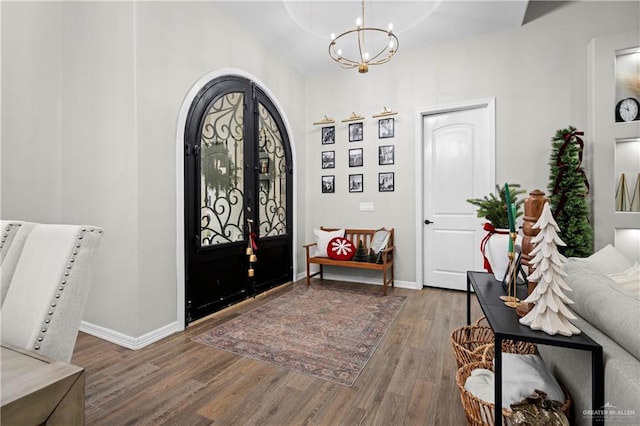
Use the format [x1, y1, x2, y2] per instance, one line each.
[0, 2, 62, 222]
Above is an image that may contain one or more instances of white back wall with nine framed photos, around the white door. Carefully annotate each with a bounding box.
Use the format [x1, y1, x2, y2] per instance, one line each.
[301, 2, 640, 282]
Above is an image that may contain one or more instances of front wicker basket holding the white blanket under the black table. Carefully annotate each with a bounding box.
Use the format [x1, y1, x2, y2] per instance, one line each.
[456, 361, 572, 426]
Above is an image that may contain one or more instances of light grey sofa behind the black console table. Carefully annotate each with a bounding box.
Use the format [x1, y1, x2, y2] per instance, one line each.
[538, 246, 640, 426]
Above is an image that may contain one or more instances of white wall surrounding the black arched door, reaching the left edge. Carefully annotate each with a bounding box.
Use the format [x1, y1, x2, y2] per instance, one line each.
[1, 2, 305, 347]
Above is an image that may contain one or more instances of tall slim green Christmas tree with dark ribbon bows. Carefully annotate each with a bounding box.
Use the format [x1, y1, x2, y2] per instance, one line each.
[548, 126, 593, 257]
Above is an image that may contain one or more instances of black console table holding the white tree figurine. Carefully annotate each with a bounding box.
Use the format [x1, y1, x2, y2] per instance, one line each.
[467, 271, 604, 425]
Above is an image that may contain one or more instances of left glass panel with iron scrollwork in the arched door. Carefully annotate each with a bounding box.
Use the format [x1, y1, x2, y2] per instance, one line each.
[200, 92, 244, 247]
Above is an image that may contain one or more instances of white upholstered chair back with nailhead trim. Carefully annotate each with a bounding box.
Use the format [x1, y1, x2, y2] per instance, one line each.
[0, 221, 102, 362]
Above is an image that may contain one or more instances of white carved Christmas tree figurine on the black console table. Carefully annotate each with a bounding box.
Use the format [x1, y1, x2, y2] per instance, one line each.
[520, 203, 580, 336]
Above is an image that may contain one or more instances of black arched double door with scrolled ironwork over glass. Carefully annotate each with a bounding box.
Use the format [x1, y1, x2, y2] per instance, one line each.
[184, 76, 293, 323]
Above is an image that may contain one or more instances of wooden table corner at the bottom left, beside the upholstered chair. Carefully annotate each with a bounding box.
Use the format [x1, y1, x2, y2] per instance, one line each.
[0, 343, 85, 425]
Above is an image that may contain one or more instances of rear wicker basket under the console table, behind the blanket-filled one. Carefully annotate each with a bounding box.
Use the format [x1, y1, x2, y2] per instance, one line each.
[449, 317, 537, 368]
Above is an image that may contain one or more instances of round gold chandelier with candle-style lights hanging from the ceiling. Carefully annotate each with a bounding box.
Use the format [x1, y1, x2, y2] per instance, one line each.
[329, 0, 400, 73]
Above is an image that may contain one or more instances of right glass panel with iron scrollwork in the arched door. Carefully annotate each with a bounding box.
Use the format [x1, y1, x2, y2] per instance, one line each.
[258, 104, 287, 237]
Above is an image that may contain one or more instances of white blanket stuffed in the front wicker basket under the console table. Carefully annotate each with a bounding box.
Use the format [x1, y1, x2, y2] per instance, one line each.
[464, 353, 565, 409]
